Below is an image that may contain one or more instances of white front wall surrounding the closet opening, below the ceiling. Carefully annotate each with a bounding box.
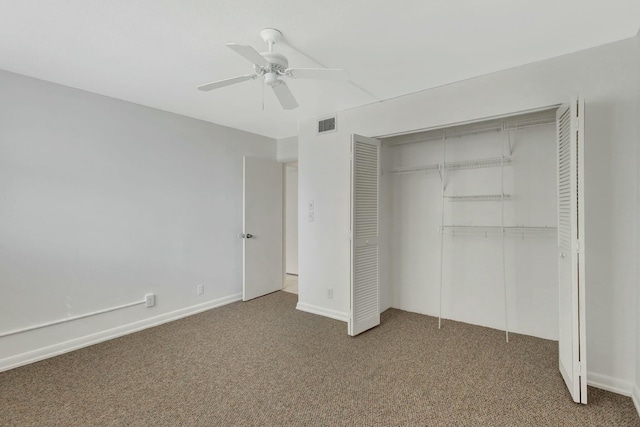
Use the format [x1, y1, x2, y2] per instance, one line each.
[299, 39, 638, 393]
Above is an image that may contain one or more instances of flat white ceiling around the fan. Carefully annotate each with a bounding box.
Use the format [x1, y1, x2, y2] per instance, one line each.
[0, 0, 640, 138]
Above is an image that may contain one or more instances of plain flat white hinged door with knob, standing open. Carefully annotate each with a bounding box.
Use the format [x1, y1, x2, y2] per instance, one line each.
[241, 157, 283, 301]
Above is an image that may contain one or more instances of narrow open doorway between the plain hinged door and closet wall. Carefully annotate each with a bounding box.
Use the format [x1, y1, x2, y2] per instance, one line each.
[282, 162, 298, 294]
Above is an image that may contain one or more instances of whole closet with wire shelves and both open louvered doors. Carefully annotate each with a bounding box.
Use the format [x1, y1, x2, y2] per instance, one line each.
[348, 99, 587, 403]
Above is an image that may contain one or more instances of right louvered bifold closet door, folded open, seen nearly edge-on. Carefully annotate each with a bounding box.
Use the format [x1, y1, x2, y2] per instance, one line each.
[556, 100, 587, 403]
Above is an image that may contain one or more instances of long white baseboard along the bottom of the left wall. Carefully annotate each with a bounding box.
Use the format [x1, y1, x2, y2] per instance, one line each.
[0, 294, 242, 372]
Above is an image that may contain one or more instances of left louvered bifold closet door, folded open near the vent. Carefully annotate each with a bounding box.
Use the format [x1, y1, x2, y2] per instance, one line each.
[349, 135, 380, 336]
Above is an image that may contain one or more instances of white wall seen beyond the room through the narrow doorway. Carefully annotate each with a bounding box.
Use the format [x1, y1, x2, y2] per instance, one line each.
[285, 163, 298, 274]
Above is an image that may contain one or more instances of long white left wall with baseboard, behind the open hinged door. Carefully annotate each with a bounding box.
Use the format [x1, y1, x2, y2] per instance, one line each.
[0, 72, 276, 369]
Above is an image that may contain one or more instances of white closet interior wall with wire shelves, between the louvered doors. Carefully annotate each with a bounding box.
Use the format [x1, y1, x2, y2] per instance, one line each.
[380, 111, 558, 340]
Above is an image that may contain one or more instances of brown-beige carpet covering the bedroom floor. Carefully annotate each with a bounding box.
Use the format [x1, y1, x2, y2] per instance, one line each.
[0, 292, 640, 426]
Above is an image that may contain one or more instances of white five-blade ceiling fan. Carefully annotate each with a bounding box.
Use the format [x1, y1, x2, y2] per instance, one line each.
[198, 28, 349, 110]
